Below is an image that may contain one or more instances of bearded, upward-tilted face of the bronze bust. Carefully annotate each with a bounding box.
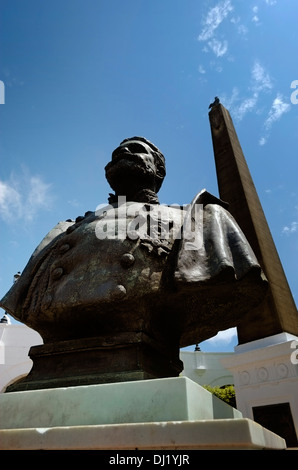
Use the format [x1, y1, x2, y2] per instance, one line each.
[105, 140, 157, 196]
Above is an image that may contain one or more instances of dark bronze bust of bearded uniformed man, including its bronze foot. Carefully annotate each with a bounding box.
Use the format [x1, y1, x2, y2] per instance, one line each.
[1, 137, 267, 391]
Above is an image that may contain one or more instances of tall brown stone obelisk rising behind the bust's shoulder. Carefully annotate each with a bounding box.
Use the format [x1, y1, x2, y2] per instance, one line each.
[209, 100, 298, 344]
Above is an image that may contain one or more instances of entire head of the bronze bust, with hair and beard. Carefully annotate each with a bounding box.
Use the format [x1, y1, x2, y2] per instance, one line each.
[105, 137, 166, 200]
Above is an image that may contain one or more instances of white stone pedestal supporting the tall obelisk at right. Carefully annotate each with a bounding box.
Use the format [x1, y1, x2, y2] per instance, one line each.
[222, 333, 298, 447]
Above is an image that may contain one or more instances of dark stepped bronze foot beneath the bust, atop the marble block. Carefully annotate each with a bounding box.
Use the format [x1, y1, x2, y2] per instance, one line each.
[6, 332, 183, 392]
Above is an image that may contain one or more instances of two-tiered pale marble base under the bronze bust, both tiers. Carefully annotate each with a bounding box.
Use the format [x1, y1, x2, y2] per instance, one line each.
[0, 377, 285, 450]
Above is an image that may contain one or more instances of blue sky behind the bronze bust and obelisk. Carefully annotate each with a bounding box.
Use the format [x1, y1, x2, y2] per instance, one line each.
[0, 0, 298, 351]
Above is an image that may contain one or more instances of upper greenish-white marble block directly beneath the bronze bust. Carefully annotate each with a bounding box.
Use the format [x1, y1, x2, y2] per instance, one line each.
[0, 377, 242, 429]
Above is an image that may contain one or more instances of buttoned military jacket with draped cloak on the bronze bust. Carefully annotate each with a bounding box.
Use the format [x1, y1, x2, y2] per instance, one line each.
[1, 190, 266, 346]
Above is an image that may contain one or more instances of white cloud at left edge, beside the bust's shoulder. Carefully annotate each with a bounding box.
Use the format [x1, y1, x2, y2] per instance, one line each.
[0, 174, 52, 222]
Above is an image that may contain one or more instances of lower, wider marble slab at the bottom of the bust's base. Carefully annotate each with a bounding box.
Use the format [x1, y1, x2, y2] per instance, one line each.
[0, 419, 286, 450]
